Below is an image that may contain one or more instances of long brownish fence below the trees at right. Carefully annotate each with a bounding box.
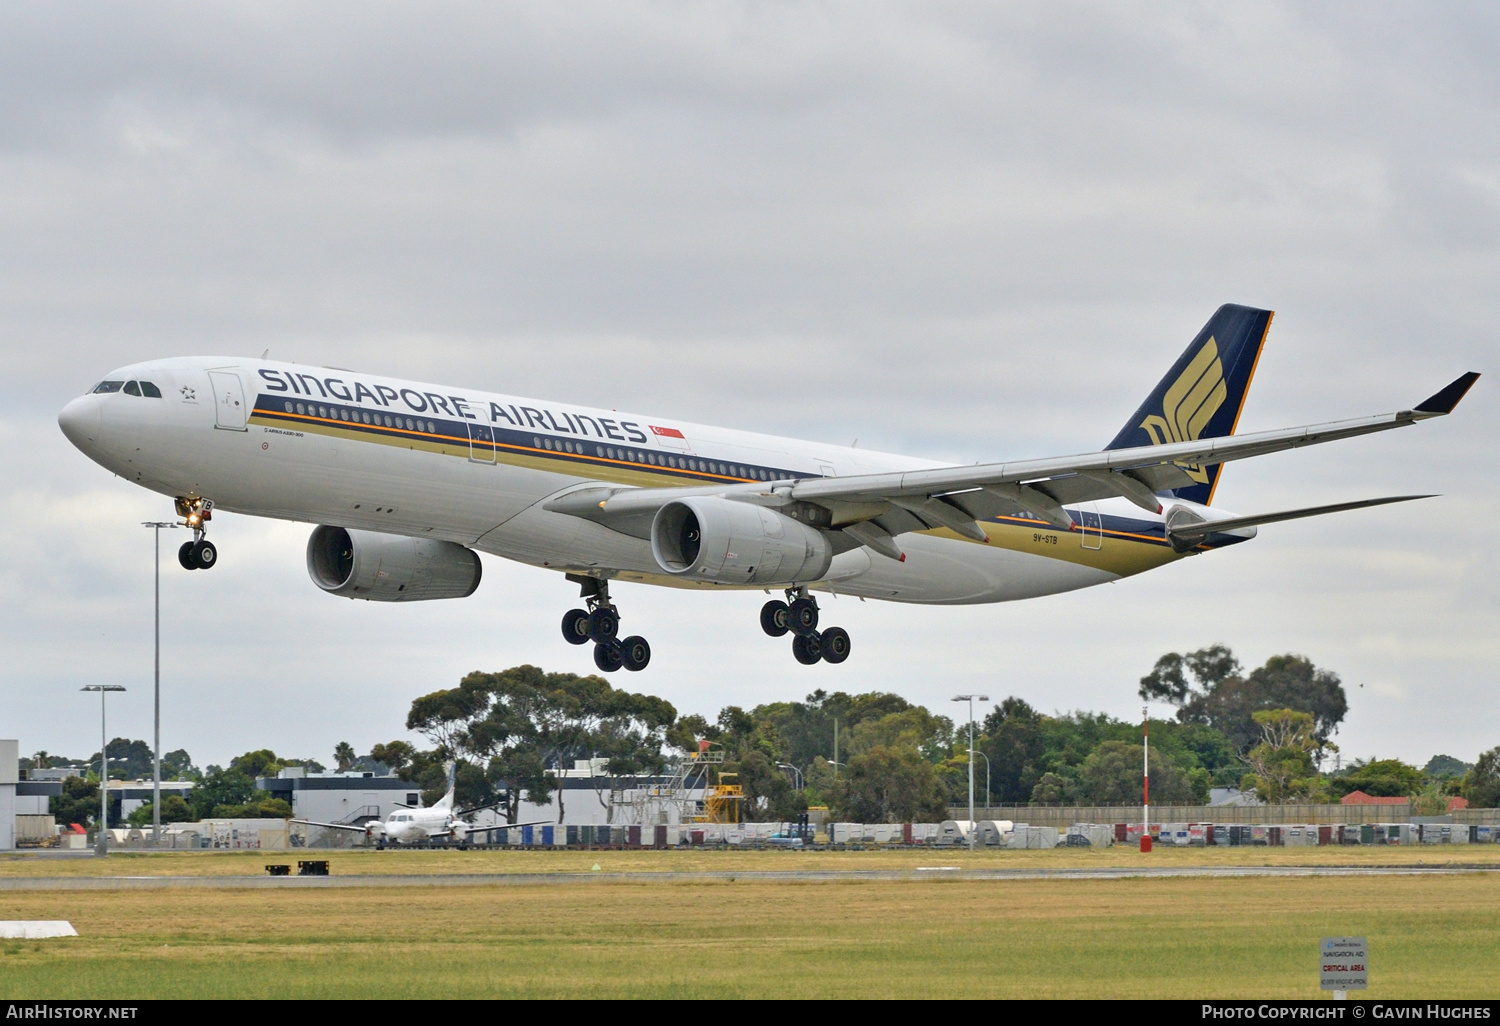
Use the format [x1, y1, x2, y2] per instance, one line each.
[948, 803, 1500, 830]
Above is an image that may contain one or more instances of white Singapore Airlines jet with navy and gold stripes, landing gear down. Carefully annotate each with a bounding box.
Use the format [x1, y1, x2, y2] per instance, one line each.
[59, 306, 1479, 672]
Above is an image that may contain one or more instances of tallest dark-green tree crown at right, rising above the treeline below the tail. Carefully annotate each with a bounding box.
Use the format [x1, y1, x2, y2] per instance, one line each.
[1139, 645, 1349, 759]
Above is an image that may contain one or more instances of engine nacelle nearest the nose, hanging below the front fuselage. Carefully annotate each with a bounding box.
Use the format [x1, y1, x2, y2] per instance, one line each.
[308, 527, 483, 602]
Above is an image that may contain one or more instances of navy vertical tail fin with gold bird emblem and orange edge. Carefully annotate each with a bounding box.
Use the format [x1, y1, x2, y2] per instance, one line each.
[1106, 303, 1271, 506]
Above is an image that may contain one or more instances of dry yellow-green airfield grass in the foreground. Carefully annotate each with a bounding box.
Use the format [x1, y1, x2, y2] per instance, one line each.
[0, 849, 1500, 999]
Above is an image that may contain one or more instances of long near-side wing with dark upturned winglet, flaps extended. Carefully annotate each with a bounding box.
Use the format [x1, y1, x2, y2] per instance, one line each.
[543, 372, 1479, 546]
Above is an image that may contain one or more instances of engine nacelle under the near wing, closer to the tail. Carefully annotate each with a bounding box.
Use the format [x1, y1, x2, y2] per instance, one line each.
[651, 495, 834, 585]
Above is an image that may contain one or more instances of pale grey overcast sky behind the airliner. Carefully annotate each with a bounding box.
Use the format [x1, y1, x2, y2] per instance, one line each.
[0, 0, 1500, 765]
